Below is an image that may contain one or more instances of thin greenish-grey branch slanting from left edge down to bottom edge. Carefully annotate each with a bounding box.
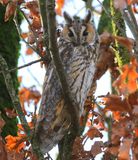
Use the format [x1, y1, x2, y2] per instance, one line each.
[0, 54, 44, 160]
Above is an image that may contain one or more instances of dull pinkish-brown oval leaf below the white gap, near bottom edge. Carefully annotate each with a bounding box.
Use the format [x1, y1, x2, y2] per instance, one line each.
[91, 141, 104, 157]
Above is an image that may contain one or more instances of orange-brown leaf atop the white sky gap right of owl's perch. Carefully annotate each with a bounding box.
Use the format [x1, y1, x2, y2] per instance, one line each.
[86, 127, 103, 139]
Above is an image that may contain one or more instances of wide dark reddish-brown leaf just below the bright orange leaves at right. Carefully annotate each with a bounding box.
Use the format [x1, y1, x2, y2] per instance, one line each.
[102, 95, 131, 112]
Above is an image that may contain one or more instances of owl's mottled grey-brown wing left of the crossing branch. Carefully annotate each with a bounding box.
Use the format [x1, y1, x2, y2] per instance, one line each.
[36, 63, 69, 153]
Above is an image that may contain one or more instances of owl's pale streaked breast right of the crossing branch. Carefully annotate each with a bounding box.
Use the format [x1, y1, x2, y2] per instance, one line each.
[59, 43, 95, 114]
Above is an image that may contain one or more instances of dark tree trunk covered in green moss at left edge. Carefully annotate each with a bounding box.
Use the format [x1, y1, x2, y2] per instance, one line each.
[0, 4, 21, 137]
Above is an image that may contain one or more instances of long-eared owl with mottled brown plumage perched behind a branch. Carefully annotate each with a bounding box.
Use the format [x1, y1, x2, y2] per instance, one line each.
[36, 11, 99, 153]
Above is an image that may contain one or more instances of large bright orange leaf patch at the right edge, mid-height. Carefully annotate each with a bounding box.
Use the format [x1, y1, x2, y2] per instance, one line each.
[113, 58, 138, 94]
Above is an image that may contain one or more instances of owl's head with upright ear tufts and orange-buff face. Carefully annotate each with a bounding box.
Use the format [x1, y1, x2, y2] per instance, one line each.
[61, 10, 95, 46]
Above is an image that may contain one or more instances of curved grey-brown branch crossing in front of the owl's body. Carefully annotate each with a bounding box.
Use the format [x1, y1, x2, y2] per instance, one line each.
[46, 0, 79, 131]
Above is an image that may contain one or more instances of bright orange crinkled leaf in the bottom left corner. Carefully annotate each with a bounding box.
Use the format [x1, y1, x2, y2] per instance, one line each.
[5, 134, 27, 153]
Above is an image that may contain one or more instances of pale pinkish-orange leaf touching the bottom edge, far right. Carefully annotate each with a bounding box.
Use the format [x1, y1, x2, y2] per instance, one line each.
[118, 138, 132, 160]
